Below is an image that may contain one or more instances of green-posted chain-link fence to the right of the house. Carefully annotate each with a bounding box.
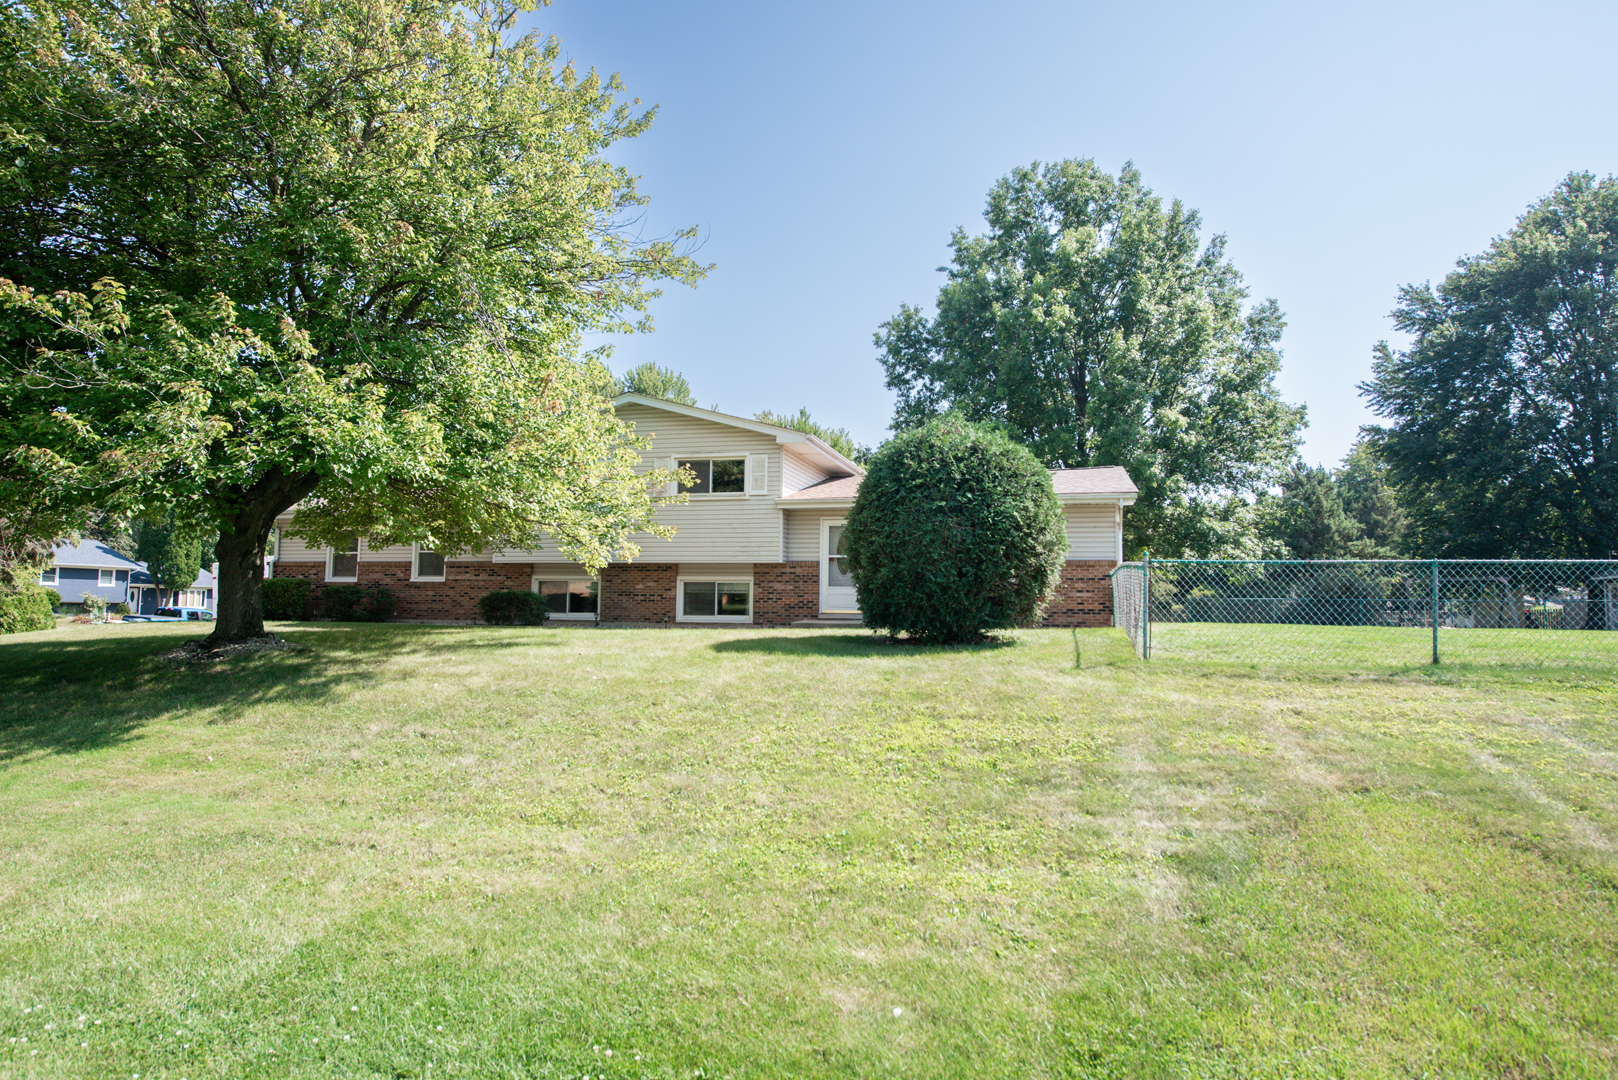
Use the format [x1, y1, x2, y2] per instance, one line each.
[1113, 559, 1618, 669]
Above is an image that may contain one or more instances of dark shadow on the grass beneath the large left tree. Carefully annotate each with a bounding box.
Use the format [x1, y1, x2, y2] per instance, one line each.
[0, 623, 555, 766]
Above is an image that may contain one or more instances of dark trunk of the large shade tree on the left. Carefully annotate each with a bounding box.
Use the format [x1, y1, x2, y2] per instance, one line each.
[205, 470, 320, 646]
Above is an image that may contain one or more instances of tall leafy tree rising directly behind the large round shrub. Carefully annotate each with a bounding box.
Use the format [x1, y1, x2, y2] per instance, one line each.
[875, 160, 1304, 554]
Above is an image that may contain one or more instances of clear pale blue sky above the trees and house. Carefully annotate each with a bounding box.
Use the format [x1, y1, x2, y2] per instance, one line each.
[527, 0, 1618, 463]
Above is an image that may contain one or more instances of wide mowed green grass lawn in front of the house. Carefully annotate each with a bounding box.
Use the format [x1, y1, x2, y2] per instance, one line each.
[0, 625, 1618, 1080]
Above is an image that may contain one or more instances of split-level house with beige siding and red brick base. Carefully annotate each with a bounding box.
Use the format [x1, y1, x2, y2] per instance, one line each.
[270, 393, 1137, 627]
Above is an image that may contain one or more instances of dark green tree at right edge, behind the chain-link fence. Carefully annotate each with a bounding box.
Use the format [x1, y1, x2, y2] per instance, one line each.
[1361, 173, 1618, 559]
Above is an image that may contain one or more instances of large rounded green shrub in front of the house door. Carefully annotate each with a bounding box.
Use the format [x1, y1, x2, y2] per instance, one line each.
[843, 415, 1068, 643]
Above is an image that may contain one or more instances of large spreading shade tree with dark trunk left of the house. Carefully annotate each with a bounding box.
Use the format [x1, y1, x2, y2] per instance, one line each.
[0, 0, 702, 640]
